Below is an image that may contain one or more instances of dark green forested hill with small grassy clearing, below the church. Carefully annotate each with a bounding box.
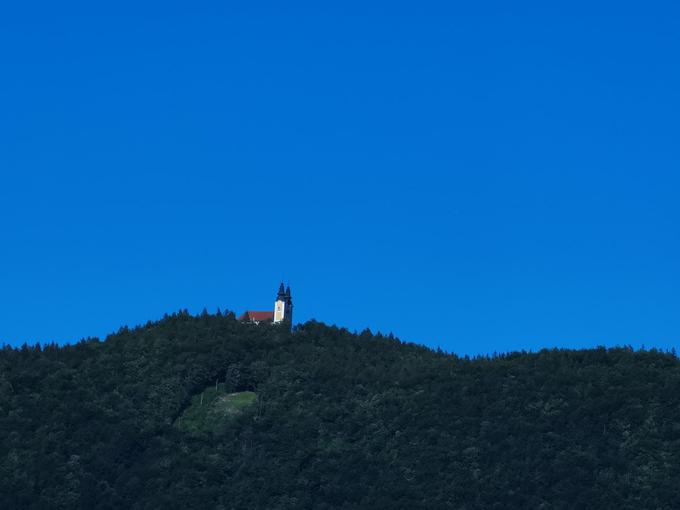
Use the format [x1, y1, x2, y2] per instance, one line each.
[0, 313, 680, 510]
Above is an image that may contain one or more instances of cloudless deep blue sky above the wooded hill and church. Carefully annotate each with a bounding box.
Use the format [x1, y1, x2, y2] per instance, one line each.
[0, 1, 680, 354]
